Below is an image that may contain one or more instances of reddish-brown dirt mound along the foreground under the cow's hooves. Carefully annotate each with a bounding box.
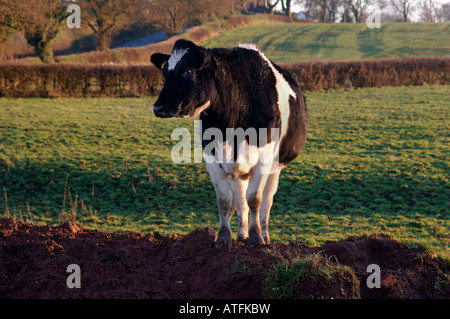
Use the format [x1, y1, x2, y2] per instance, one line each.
[0, 219, 450, 299]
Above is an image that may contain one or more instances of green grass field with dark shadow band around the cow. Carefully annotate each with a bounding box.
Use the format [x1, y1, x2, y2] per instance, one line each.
[0, 86, 450, 258]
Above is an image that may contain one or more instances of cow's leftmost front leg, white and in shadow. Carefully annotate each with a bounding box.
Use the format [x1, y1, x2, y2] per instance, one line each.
[206, 163, 233, 247]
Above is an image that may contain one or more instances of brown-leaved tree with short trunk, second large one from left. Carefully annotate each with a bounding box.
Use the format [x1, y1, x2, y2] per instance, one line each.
[77, 0, 141, 51]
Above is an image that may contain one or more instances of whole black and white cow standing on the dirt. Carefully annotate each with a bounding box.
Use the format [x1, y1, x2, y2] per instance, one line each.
[151, 40, 308, 246]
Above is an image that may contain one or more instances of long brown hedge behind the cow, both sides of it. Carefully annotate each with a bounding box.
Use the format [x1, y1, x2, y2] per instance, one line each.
[0, 57, 450, 97]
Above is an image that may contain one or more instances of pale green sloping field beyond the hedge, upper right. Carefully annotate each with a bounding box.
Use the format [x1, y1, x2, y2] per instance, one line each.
[203, 23, 450, 62]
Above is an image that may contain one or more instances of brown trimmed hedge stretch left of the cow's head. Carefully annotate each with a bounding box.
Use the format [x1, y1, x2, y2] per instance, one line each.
[0, 63, 164, 97]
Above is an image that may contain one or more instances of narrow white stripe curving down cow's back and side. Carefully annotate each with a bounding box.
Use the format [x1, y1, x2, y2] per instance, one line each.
[238, 43, 297, 140]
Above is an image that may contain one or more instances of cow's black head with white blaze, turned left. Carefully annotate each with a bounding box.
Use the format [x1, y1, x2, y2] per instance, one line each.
[151, 39, 211, 117]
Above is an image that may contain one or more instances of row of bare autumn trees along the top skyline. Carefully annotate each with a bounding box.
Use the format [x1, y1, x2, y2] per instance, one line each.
[0, 0, 450, 62]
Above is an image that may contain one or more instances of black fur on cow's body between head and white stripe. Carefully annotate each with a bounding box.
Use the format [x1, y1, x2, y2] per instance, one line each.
[200, 48, 281, 146]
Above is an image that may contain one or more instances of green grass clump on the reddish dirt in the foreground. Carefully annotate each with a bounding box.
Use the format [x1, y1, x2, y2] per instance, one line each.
[262, 253, 359, 299]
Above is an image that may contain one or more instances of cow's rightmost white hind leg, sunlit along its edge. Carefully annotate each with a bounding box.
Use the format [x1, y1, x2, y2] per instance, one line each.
[259, 170, 281, 244]
